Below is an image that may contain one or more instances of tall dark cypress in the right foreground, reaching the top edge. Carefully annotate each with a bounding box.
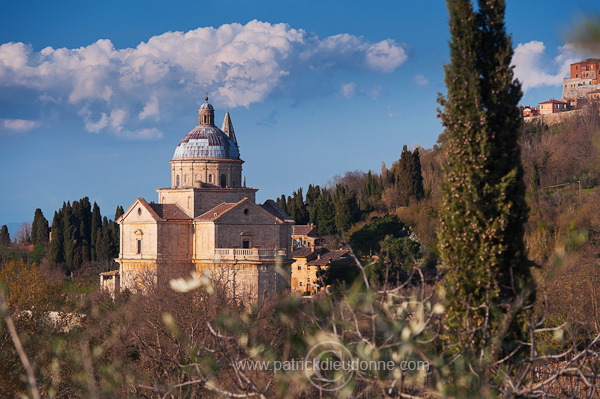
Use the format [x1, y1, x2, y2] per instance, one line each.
[439, 0, 534, 362]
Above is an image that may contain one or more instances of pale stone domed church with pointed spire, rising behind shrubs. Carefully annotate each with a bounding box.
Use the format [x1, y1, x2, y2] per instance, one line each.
[100, 97, 294, 300]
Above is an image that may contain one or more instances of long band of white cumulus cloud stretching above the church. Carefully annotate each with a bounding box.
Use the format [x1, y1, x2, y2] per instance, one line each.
[0, 20, 407, 139]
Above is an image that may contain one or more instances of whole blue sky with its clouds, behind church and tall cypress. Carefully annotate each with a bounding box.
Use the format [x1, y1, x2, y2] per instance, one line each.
[0, 0, 600, 225]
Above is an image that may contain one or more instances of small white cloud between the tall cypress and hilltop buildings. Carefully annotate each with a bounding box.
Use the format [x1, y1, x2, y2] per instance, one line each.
[513, 40, 579, 91]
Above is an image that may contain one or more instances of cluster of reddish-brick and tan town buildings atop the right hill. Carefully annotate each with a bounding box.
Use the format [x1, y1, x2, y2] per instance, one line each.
[520, 58, 600, 123]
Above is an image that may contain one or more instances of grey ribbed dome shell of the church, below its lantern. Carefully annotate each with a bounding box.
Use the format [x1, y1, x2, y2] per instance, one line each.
[173, 127, 240, 159]
